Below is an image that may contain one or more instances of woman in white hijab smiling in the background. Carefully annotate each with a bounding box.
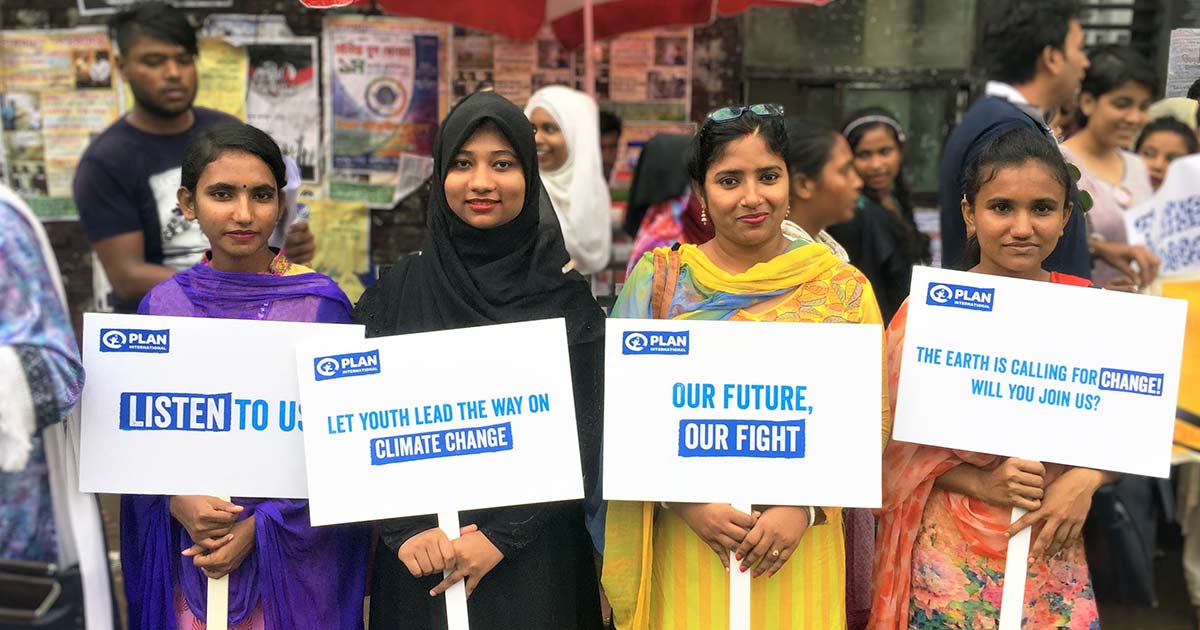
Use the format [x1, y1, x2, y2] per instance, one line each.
[526, 85, 612, 274]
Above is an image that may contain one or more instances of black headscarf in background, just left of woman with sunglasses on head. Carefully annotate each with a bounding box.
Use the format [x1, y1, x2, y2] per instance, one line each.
[623, 133, 691, 236]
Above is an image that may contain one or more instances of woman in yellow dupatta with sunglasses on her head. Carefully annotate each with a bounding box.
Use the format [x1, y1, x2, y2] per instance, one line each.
[604, 106, 887, 630]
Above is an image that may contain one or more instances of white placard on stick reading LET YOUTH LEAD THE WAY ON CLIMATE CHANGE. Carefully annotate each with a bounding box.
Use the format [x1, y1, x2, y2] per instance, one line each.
[295, 319, 583, 630]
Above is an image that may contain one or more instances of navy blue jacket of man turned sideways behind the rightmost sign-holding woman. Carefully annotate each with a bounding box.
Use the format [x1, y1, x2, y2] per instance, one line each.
[937, 96, 1092, 280]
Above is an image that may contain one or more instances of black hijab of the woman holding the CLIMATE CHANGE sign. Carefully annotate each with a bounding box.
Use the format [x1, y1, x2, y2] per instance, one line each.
[354, 92, 604, 344]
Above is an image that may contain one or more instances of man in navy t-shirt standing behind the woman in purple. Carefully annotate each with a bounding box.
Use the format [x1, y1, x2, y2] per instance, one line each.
[72, 1, 314, 313]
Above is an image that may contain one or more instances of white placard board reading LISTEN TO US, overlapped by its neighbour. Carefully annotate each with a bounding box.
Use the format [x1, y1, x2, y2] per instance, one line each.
[79, 313, 364, 498]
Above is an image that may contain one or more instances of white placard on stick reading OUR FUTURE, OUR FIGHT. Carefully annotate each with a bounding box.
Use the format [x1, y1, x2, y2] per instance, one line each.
[604, 319, 882, 630]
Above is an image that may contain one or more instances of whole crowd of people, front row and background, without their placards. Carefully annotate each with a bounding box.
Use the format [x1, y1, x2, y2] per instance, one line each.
[0, 0, 1200, 630]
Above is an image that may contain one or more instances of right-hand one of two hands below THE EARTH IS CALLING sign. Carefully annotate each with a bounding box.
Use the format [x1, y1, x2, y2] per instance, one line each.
[1004, 468, 1104, 564]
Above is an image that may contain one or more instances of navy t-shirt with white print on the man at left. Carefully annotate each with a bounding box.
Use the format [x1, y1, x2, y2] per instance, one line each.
[72, 107, 238, 312]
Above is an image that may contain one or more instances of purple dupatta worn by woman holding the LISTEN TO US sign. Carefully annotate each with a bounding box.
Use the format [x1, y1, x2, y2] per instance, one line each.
[121, 256, 370, 630]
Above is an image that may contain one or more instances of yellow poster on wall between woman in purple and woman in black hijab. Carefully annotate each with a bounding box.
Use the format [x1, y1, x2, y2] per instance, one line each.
[307, 199, 371, 304]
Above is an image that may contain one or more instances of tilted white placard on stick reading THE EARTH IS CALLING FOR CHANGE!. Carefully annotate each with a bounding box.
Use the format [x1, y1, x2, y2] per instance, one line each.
[892, 268, 1187, 630]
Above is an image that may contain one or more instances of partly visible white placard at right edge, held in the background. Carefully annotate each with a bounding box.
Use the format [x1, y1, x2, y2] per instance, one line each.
[1124, 153, 1200, 277]
